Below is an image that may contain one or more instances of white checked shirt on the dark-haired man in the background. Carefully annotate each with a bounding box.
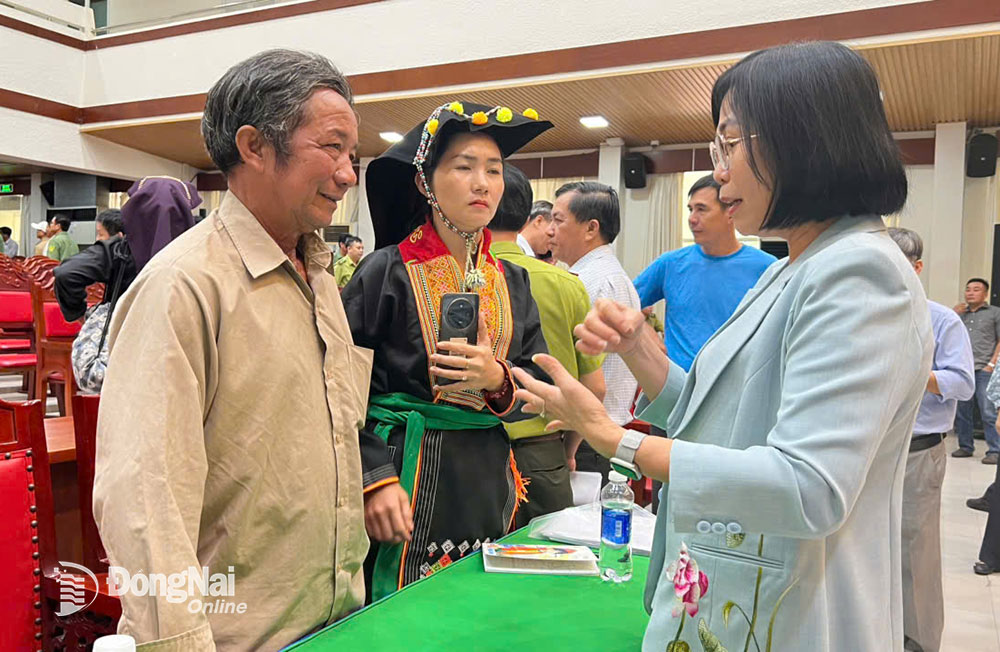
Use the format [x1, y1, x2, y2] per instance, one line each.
[569, 245, 641, 425]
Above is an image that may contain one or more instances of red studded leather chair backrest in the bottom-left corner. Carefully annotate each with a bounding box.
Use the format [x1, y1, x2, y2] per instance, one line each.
[0, 400, 56, 650]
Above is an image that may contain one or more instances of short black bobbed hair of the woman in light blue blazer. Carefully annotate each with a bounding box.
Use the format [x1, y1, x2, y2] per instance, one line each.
[712, 41, 906, 229]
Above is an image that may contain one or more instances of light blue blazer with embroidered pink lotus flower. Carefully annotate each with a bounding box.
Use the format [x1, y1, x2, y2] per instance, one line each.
[639, 216, 934, 652]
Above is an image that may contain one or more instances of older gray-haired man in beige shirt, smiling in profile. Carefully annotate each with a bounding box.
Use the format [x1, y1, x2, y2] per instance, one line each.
[94, 50, 371, 652]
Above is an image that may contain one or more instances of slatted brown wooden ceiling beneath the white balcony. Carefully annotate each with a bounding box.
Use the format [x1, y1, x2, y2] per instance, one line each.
[86, 34, 1000, 169]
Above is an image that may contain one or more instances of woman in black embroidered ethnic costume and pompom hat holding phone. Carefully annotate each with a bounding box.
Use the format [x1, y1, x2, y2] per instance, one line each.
[342, 102, 552, 600]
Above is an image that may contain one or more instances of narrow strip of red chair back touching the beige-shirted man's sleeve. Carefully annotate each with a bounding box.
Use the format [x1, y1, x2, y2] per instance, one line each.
[73, 394, 108, 573]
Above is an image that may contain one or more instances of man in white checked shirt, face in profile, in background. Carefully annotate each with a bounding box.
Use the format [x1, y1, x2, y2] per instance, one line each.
[552, 181, 641, 480]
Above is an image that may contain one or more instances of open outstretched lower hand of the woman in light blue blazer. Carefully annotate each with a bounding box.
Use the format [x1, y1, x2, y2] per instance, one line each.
[514, 354, 616, 457]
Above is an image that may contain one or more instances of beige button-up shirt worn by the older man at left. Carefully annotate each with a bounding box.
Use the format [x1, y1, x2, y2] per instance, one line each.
[94, 193, 371, 652]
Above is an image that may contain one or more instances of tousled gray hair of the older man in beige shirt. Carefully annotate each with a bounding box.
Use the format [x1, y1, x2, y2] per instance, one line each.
[201, 49, 354, 174]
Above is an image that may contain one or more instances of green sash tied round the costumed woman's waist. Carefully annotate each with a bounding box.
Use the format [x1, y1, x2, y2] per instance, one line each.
[368, 393, 501, 601]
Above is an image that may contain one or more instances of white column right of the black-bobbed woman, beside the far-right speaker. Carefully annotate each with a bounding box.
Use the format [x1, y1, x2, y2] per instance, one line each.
[924, 122, 964, 306]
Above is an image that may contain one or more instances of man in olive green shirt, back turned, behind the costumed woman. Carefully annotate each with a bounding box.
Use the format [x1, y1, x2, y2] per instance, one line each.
[489, 164, 604, 527]
